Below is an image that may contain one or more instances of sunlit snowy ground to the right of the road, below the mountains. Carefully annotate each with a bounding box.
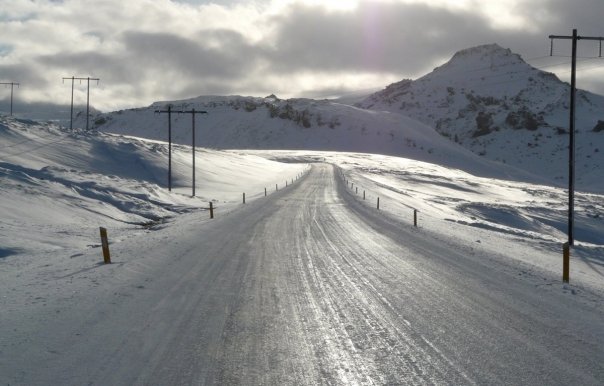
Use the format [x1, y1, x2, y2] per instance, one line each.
[252, 152, 604, 290]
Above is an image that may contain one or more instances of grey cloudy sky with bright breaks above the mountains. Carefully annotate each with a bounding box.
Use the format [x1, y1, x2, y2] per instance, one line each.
[0, 0, 604, 111]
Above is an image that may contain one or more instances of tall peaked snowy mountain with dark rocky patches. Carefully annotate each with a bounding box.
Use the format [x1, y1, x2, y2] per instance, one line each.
[357, 44, 604, 190]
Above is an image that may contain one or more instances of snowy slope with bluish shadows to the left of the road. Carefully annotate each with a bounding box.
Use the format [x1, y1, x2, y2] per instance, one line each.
[0, 116, 305, 258]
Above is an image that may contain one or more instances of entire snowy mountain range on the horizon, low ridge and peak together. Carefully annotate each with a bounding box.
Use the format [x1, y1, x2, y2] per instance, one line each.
[86, 44, 604, 191]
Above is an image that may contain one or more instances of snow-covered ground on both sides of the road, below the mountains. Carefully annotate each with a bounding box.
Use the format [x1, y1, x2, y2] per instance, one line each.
[0, 117, 604, 302]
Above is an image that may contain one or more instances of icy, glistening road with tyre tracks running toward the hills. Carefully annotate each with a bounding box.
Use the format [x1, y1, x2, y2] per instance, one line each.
[0, 165, 604, 385]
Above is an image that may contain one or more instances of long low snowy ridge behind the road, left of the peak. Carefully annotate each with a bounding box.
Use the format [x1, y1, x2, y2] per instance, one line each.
[86, 95, 534, 180]
